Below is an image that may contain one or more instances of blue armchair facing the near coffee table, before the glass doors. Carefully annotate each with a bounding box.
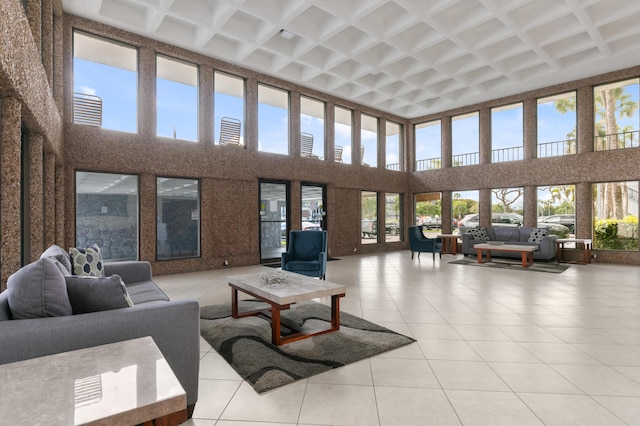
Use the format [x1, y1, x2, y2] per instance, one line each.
[282, 231, 327, 280]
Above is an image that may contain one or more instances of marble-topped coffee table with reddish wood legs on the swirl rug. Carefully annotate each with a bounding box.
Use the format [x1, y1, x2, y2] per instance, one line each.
[229, 272, 346, 345]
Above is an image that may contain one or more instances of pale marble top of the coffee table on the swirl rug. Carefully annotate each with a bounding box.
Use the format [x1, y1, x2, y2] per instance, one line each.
[229, 271, 347, 305]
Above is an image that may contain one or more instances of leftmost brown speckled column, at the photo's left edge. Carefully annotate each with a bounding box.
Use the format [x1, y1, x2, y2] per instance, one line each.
[0, 97, 22, 291]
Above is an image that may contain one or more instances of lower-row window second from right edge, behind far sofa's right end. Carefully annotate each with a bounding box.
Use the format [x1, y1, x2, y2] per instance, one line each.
[538, 185, 576, 236]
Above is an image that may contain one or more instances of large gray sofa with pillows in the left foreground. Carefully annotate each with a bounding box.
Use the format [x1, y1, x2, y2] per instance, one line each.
[0, 248, 200, 417]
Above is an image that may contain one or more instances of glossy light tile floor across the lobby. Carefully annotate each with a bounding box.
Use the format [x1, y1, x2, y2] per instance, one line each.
[155, 251, 640, 426]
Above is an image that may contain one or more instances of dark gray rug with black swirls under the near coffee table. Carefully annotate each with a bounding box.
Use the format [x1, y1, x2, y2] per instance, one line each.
[200, 301, 415, 393]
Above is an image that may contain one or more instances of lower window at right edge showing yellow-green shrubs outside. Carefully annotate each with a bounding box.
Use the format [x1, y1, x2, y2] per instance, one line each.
[593, 181, 639, 251]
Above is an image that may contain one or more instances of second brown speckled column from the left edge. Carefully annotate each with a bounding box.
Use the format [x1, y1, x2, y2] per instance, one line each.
[29, 134, 44, 262]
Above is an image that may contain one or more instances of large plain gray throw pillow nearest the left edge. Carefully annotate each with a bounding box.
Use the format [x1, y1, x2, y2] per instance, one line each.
[7, 258, 73, 319]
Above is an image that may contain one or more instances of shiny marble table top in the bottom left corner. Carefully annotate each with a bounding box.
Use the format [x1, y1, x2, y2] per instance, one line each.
[0, 337, 187, 425]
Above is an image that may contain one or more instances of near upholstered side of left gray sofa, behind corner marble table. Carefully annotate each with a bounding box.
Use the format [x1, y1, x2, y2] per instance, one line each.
[0, 300, 200, 405]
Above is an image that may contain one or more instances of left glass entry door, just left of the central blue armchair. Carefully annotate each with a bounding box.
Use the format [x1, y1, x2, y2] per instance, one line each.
[260, 181, 289, 263]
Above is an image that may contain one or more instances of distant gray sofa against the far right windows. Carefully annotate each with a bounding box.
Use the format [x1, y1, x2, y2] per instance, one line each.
[461, 226, 557, 260]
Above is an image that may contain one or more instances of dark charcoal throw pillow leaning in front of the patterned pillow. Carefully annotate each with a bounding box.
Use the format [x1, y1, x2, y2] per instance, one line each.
[65, 274, 133, 314]
